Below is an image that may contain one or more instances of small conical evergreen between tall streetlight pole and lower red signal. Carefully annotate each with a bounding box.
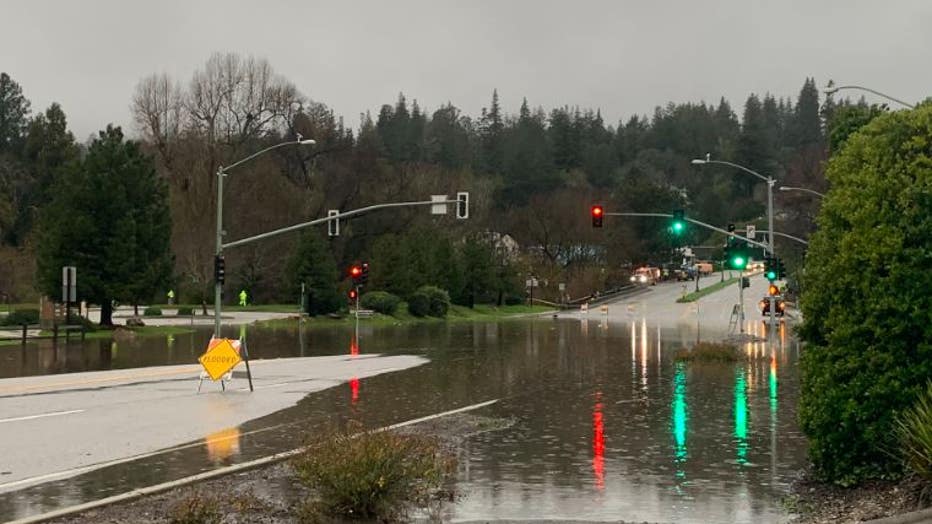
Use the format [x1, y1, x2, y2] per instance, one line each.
[285, 230, 343, 315]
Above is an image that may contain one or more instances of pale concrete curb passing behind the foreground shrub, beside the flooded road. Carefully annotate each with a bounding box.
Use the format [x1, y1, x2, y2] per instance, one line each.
[6, 399, 499, 524]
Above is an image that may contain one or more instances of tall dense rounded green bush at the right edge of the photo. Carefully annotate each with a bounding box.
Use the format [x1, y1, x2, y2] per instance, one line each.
[800, 105, 932, 484]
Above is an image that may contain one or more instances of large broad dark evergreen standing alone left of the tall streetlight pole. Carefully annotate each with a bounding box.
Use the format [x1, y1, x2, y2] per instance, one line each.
[38, 126, 172, 325]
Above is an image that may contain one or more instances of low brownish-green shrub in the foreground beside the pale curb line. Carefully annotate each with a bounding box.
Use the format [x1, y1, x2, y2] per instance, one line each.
[294, 431, 454, 519]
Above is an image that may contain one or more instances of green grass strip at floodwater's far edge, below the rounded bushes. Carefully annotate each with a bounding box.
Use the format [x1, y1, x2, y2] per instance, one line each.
[257, 302, 554, 328]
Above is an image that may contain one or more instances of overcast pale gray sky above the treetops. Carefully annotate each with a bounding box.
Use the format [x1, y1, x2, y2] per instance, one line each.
[0, 0, 932, 140]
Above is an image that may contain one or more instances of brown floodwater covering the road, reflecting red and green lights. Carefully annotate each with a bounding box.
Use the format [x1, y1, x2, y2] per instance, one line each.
[0, 318, 805, 522]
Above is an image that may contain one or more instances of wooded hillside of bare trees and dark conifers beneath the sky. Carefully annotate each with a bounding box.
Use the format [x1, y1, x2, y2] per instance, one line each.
[0, 53, 872, 314]
